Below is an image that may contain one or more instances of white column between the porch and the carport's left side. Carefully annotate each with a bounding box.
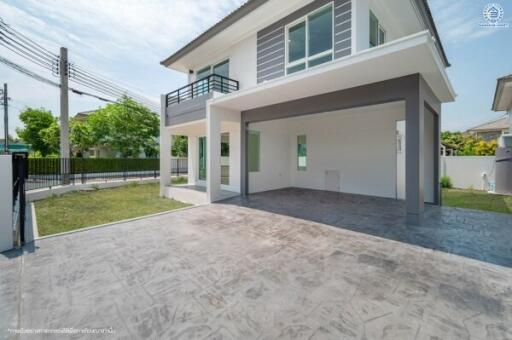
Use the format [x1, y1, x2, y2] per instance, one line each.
[206, 103, 221, 202]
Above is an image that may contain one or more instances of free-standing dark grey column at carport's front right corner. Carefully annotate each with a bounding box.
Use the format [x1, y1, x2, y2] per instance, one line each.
[405, 90, 425, 225]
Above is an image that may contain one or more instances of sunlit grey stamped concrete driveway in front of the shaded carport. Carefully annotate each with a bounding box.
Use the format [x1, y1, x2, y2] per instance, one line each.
[0, 190, 512, 340]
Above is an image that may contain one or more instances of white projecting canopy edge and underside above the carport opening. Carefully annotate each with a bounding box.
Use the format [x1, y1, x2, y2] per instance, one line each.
[208, 31, 456, 111]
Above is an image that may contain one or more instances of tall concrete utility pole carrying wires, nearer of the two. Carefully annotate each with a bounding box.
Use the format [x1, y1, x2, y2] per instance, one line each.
[59, 47, 70, 184]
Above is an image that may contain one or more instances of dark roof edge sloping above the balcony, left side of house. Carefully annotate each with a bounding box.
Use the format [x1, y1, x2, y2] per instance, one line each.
[160, 0, 268, 66]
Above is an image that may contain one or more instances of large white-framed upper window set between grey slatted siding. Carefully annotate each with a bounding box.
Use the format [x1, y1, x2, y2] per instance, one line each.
[286, 5, 333, 74]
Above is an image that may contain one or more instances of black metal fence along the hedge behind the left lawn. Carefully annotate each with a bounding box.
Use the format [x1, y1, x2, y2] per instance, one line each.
[26, 158, 188, 190]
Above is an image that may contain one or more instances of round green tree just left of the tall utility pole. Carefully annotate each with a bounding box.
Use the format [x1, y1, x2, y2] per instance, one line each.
[16, 107, 59, 156]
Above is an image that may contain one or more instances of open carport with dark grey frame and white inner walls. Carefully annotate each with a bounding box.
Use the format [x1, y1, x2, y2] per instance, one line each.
[241, 74, 440, 224]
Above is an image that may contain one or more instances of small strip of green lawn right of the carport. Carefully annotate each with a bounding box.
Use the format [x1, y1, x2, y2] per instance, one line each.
[443, 189, 512, 214]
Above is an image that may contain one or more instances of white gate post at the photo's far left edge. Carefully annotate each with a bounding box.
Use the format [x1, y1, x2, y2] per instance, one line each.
[0, 155, 14, 252]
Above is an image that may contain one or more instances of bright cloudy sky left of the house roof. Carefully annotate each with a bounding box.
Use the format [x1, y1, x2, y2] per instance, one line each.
[0, 0, 245, 135]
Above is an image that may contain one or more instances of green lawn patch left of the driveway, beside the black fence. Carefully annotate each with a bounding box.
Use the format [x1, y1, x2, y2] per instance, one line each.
[35, 183, 188, 236]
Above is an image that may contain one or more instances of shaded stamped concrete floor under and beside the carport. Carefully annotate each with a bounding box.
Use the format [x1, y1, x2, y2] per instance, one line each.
[226, 188, 512, 267]
